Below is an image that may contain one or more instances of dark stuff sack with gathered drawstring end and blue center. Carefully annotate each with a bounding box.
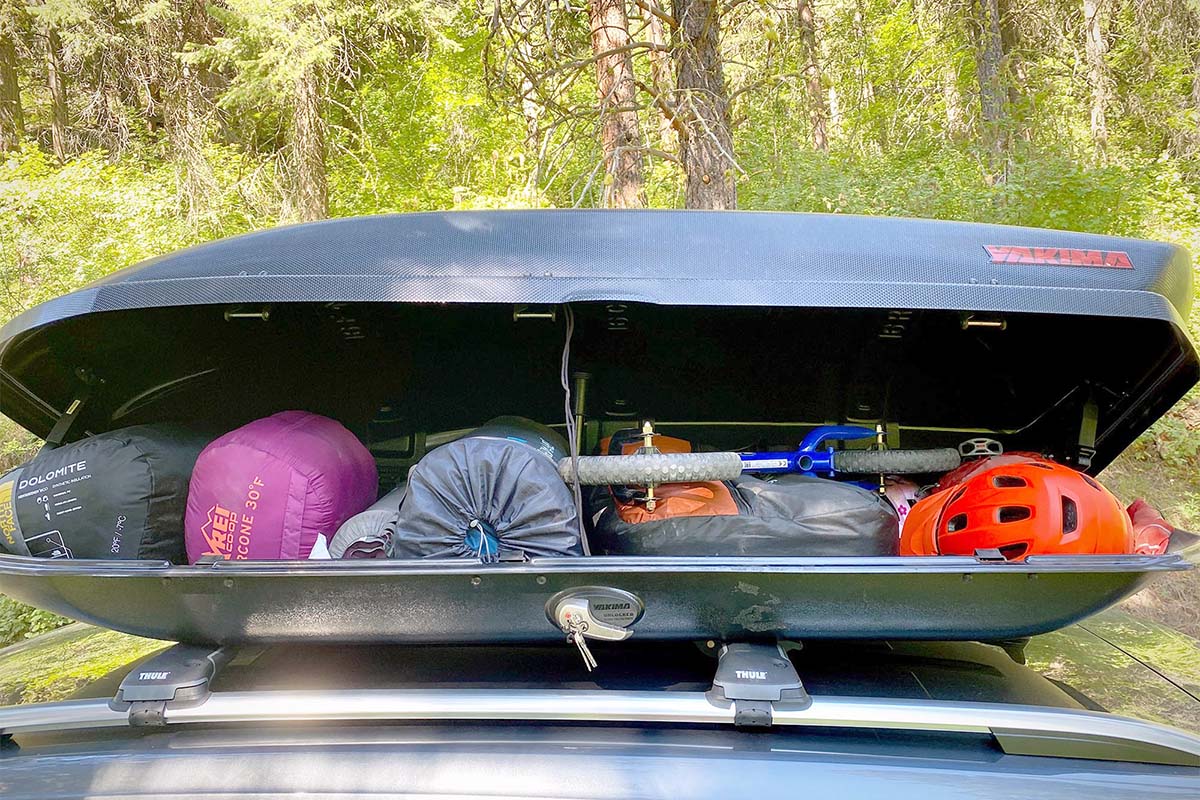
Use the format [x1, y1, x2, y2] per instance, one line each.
[391, 417, 583, 563]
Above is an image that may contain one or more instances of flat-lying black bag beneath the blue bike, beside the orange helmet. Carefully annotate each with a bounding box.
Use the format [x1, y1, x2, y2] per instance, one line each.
[588, 475, 900, 557]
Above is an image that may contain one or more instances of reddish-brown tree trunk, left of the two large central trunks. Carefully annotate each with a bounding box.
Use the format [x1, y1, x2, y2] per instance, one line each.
[588, 0, 646, 209]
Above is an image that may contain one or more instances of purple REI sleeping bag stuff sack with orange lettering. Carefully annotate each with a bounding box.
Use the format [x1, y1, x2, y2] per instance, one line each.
[184, 411, 379, 564]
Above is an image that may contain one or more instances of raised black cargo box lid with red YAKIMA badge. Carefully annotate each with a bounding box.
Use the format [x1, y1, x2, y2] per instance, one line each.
[0, 211, 1200, 471]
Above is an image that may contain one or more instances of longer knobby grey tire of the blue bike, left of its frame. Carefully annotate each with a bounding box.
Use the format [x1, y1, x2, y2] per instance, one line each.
[558, 452, 742, 486]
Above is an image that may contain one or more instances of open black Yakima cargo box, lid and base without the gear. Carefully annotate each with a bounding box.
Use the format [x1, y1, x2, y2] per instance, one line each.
[0, 211, 1198, 642]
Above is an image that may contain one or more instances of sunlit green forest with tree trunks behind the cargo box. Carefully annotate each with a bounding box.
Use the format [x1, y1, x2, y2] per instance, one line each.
[0, 0, 1200, 643]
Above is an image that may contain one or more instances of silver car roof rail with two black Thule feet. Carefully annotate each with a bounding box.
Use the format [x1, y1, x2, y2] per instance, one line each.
[0, 644, 1200, 768]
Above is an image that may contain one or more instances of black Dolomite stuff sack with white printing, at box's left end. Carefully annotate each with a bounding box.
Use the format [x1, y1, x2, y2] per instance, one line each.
[0, 425, 206, 564]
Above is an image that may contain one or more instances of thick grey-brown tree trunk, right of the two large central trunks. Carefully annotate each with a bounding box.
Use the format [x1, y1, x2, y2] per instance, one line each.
[674, 0, 738, 209]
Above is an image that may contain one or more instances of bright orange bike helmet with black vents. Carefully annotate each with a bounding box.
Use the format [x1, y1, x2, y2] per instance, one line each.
[900, 453, 1133, 561]
